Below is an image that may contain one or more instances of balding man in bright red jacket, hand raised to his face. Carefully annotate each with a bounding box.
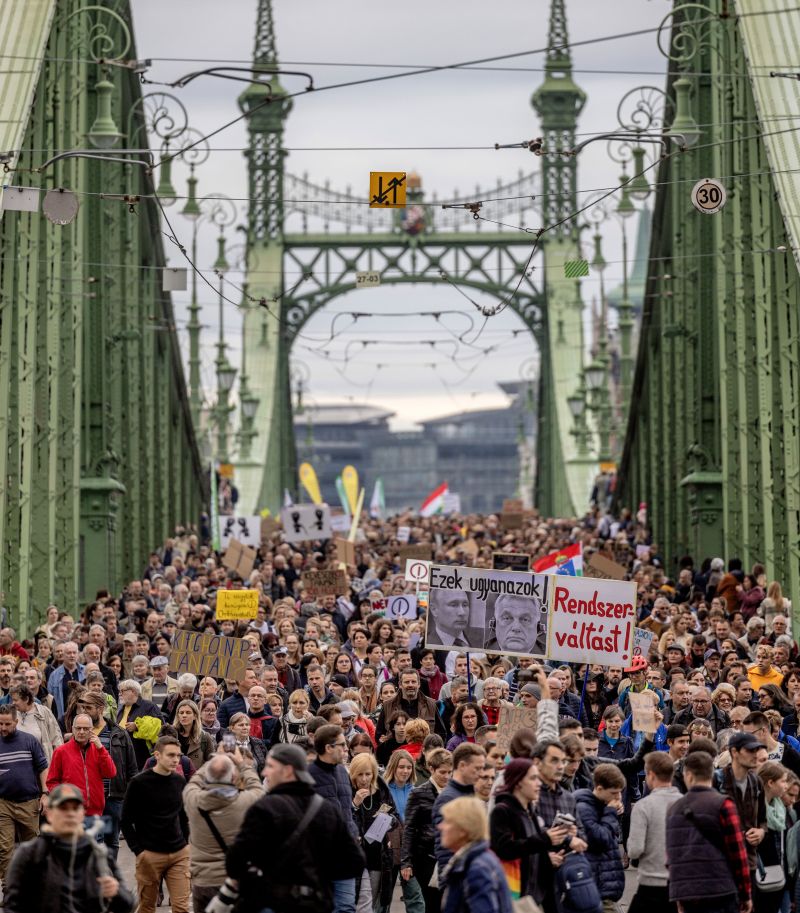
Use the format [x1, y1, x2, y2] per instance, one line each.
[47, 713, 117, 817]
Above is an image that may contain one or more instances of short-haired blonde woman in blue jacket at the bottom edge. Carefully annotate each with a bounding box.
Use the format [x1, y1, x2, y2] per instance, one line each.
[439, 796, 513, 913]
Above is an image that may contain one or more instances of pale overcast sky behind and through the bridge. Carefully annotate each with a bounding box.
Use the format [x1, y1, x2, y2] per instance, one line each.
[132, 0, 670, 428]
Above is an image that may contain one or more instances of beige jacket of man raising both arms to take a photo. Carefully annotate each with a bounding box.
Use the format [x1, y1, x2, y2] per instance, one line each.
[183, 764, 264, 887]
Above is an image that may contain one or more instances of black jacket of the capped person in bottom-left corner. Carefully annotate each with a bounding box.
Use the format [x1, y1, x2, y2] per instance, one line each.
[3, 833, 134, 913]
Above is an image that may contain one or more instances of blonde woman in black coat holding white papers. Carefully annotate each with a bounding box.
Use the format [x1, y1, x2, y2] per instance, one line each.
[349, 754, 400, 913]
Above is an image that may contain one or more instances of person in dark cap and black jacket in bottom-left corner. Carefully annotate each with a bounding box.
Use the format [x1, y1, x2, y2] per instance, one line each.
[3, 783, 134, 913]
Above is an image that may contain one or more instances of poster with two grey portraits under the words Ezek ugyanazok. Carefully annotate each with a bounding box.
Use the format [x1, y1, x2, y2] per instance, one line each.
[425, 564, 550, 657]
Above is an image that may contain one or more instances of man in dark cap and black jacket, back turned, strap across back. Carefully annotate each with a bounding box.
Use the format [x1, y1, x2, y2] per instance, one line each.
[216, 745, 366, 913]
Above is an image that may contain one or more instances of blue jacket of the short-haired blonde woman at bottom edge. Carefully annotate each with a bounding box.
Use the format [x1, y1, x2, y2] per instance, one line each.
[440, 840, 513, 913]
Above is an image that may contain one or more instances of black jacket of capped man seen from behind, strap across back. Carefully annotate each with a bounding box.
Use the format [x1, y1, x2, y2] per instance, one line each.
[225, 782, 364, 913]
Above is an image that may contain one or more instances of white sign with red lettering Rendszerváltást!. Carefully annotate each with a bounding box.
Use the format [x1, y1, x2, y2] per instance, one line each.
[547, 575, 636, 666]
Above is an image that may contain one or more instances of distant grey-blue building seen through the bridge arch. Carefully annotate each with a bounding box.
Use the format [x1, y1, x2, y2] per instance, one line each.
[295, 381, 536, 513]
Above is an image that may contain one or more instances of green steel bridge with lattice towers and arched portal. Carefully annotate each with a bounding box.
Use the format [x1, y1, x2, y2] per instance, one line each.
[0, 0, 800, 630]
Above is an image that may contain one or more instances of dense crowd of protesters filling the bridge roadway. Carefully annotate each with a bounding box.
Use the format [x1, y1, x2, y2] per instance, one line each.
[0, 509, 800, 913]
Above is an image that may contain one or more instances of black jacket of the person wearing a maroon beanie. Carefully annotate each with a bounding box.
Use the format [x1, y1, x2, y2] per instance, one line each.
[489, 793, 553, 903]
